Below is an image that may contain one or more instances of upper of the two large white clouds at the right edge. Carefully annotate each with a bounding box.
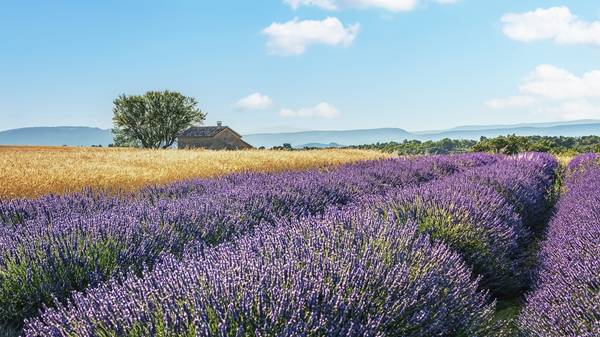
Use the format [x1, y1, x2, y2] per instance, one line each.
[501, 6, 600, 45]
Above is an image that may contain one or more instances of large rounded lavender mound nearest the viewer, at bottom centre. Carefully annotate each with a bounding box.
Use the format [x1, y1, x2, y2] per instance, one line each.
[25, 209, 499, 337]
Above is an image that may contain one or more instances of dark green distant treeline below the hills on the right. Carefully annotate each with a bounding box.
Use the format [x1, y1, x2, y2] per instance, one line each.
[351, 135, 600, 155]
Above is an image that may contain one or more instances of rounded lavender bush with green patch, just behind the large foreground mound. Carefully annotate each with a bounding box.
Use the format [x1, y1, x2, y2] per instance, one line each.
[372, 179, 529, 296]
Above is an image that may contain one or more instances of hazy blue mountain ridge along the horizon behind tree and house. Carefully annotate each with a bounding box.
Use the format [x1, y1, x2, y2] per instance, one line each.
[0, 120, 600, 147]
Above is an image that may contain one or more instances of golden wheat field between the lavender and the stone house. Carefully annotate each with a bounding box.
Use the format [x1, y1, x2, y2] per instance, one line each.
[0, 147, 386, 200]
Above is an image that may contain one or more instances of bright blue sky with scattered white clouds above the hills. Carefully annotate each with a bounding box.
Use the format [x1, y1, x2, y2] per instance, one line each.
[0, 0, 600, 133]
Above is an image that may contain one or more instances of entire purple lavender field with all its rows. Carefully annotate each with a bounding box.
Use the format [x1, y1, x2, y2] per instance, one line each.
[0, 153, 600, 337]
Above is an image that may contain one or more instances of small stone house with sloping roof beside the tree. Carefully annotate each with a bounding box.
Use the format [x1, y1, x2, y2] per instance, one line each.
[177, 122, 252, 150]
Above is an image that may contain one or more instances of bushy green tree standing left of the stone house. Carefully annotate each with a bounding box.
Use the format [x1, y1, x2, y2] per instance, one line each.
[113, 91, 206, 149]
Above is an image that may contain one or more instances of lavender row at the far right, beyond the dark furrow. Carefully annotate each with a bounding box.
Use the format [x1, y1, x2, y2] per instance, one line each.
[519, 154, 600, 337]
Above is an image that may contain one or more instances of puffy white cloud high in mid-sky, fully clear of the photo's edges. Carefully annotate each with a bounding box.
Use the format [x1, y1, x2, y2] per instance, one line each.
[263, 17, 360, 55]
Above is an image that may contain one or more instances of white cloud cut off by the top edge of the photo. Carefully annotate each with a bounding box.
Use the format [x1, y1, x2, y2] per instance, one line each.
[283, 0, 452, 12]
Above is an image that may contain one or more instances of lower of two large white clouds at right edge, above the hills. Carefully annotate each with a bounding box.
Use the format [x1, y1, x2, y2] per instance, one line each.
[485, 64, 600, 119]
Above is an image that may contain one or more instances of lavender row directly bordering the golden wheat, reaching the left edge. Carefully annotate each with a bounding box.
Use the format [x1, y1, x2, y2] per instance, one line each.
[0, 155, 497, 324]
